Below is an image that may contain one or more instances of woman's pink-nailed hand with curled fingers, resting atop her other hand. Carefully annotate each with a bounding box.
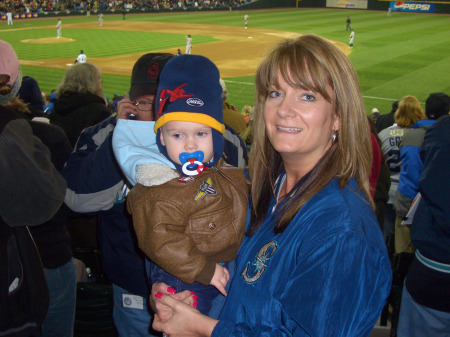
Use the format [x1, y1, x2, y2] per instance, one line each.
[149, 283, 198, 321]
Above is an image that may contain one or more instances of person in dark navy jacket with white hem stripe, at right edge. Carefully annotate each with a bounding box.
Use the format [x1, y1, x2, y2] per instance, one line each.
[397, 113, 450, 337]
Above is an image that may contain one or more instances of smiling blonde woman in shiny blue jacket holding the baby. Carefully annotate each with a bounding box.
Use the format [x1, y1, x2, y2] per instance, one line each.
[151, 35, 391, 337]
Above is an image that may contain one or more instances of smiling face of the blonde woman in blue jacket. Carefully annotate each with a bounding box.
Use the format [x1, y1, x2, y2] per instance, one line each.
[264, 75, 339, 165]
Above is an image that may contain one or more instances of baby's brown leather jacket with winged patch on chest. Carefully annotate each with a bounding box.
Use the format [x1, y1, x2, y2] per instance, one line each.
[127, 160, 249, 285]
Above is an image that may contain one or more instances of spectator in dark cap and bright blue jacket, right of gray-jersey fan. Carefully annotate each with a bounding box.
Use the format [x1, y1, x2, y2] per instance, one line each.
[394, 93, 450, 253]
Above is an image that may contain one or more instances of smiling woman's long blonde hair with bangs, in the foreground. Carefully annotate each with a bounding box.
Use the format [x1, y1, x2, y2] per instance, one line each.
[249, 35, 373, 234]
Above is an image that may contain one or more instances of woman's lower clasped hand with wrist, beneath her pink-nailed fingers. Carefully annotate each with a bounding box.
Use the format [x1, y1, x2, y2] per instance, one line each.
[152, 293, 218, 337]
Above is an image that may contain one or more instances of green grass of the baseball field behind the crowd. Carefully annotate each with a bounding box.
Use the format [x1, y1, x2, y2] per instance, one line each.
[0, 8, 450, 113]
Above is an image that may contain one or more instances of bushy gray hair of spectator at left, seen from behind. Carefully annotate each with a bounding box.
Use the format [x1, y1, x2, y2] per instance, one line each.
[56, 62, 103, 98]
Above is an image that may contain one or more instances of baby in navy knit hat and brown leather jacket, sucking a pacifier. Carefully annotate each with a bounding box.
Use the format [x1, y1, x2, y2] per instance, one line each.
[127, 55, 248, 314]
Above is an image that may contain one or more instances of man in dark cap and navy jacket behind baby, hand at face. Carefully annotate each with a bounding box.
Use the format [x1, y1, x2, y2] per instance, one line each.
[63, 53, 246, 337]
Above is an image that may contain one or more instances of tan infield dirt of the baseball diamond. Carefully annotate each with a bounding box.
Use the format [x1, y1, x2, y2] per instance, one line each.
[20, 21, 349, 78]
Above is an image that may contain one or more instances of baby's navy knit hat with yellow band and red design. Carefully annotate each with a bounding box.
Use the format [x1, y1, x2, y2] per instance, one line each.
[155, 55, 225, 175]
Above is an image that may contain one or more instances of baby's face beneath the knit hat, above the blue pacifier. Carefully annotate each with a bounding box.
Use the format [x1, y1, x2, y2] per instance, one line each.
[161, 121, 214, 165]
